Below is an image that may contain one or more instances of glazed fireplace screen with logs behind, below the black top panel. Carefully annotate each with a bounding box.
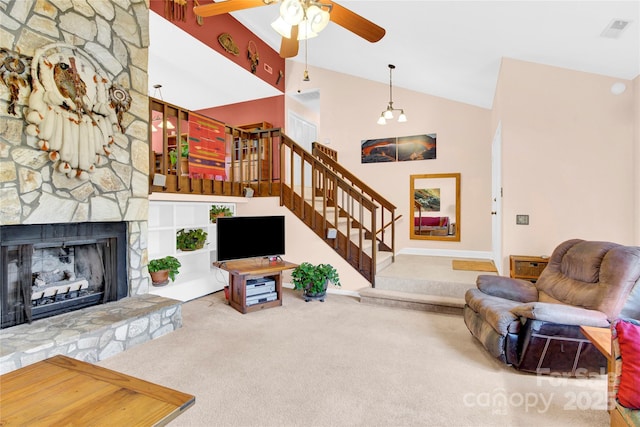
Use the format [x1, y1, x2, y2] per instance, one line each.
[0, 222, 127, 328]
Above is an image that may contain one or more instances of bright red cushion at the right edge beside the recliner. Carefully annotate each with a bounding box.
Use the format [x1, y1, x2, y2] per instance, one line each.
[615, 320, 640, 409]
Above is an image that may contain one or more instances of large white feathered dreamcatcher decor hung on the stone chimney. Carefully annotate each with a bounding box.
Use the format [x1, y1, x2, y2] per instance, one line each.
[26, 43, 131, 180]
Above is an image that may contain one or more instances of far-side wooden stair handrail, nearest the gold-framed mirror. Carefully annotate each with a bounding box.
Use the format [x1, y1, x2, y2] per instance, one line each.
[313, 142, 402, 261]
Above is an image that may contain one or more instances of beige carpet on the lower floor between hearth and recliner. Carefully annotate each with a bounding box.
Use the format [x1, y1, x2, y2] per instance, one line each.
[99, 289, 608, 427]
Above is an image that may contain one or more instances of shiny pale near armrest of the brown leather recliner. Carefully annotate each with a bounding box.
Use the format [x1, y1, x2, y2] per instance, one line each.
[511, 302, 609, 328]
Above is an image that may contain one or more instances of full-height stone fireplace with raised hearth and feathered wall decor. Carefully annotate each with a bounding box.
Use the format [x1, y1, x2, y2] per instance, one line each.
[0, 0, 182, 373]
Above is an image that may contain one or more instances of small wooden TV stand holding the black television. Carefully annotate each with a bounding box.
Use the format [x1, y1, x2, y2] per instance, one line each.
[214, 258, 297, 314]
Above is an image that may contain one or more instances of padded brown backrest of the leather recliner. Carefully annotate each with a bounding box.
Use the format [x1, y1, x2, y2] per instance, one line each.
[536, 239, 640, 320]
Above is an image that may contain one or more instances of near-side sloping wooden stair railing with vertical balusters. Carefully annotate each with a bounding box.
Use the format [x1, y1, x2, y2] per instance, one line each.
[280, 134, 395, 287]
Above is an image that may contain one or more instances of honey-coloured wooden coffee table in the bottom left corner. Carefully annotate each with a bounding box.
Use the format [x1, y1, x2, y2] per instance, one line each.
[0, 356, 195, 427]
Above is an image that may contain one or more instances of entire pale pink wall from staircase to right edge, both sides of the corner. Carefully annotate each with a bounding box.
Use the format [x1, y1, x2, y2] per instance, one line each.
[287, 59, 640, 272]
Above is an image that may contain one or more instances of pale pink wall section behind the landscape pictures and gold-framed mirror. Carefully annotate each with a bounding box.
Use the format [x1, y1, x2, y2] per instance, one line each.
[286, 62, 492, 251]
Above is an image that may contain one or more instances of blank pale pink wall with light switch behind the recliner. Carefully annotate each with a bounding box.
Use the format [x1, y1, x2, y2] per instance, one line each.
[494, 59, 638, 268]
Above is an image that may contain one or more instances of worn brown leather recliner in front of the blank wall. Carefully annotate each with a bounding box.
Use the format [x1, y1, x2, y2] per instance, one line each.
[464, 239, 640, 376]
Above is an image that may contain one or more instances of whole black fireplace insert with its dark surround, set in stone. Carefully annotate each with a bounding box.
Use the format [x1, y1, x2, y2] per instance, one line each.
[0, 223, 128, 328]
